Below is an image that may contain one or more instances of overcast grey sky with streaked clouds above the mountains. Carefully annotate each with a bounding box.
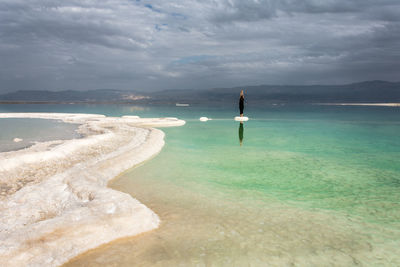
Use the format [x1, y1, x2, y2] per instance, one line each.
[0, 0, 400, 92]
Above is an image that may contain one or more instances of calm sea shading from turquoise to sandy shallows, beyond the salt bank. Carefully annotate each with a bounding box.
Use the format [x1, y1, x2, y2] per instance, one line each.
[0, 105, 400, 266]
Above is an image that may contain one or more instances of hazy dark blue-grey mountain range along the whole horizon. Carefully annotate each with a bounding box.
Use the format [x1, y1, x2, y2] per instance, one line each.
[0, 81, 400, 105]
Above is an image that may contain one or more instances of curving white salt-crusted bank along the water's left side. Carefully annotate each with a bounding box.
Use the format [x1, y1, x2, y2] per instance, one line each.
[0, 113, 185, 266]
